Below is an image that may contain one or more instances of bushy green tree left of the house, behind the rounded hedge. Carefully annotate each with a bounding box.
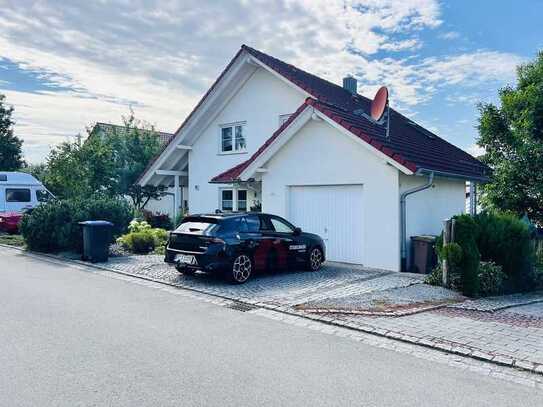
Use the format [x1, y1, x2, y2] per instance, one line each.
[43, 113, 165, 209]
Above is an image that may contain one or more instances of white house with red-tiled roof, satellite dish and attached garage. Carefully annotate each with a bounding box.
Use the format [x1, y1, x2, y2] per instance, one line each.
[138, 45, 488, 270]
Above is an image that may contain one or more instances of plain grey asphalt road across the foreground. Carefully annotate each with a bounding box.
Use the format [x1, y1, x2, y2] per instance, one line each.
[0, 247, 543, 407]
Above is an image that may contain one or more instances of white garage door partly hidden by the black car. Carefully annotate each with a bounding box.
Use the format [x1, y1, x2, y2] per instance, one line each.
[288, 185, 363, 264]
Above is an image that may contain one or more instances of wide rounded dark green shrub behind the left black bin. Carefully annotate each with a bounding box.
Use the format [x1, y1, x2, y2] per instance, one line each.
[21, 198, 132, 252]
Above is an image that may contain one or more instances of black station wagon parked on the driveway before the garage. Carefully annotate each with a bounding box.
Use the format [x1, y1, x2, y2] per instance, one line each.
[164, 213, 326, 284]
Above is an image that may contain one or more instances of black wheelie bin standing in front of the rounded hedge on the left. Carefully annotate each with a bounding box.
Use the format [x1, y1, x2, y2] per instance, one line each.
[79, 220, 113, 263]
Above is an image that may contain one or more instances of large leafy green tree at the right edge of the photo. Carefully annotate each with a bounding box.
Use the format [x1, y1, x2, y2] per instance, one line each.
[478, 51, 543, 225]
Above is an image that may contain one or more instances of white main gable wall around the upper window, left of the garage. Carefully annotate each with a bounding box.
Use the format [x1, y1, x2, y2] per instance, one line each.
[189, 68, 304, 213]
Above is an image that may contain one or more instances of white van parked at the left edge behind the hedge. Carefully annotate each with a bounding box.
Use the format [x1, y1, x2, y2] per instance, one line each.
[0, 172, 53, 212]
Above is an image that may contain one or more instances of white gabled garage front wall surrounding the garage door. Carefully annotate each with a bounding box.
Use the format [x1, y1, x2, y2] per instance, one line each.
[262, 121, 400, 270]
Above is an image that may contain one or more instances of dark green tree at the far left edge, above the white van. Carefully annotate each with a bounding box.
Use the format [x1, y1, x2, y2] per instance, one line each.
[0, 94, 24, 171]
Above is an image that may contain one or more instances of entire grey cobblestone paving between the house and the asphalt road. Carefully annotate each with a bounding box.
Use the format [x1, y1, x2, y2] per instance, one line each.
[103, 256, 543, 374]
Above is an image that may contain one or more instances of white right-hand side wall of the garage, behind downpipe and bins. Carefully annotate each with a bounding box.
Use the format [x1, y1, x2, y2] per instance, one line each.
[400, 174, 466, 266]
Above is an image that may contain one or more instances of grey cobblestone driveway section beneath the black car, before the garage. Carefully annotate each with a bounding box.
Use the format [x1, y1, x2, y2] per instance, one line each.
[107, 256, 423, 306]
